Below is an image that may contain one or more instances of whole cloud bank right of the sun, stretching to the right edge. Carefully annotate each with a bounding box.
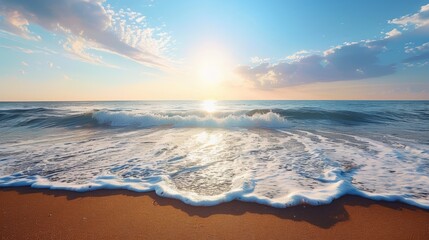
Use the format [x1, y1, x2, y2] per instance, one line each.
[236, 4, 429, 89]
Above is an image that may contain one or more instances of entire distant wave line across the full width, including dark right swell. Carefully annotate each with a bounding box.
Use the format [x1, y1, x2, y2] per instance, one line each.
[0, 108, 429, 128]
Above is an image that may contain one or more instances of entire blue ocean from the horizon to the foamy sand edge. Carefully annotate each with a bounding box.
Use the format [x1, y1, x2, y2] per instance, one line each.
[0, 101, 429, 209]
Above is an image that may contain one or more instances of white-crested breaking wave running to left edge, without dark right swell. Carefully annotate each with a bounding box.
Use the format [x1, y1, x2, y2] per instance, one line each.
[0, 109, 288, 128]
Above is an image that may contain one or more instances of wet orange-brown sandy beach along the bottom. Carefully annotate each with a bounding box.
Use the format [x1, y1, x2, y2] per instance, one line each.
[0, 188, 429, 239]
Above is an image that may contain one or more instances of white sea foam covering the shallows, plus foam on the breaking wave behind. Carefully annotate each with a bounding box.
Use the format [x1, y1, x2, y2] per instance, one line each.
[0, 126, 429, 209]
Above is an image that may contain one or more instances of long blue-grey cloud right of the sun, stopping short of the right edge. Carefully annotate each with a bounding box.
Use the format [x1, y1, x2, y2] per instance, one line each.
[236, 40, 395, 89]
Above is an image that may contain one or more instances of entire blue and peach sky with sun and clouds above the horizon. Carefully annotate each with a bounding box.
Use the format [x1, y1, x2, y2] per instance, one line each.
[0, 0, 429, 101]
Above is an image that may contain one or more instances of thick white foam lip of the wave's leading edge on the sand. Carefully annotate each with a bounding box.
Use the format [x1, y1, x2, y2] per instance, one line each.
[0, 175, 429, 210]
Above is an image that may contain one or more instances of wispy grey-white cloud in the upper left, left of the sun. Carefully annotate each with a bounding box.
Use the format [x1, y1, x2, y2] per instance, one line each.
[0, 0, 168, 67]
